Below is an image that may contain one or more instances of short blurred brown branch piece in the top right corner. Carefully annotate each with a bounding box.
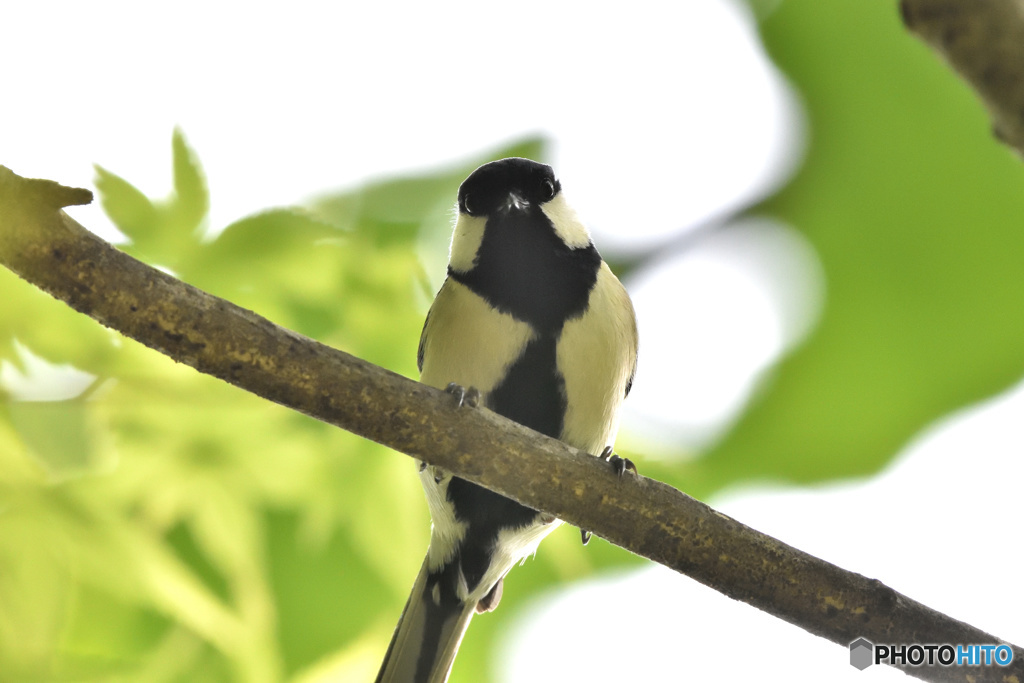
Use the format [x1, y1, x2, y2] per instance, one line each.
[900, 0, 1024, 156]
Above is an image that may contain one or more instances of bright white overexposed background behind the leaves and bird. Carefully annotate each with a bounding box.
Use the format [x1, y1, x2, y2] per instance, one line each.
[0, 0, 1024, 682]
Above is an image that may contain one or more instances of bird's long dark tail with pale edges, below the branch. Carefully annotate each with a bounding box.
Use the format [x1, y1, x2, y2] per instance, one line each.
[377, 560, 476, 683]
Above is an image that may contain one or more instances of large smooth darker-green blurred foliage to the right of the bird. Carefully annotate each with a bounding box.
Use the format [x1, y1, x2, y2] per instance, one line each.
[671, 0, 1024, 496]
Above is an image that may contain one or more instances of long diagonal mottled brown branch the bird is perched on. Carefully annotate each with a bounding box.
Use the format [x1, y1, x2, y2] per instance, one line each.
[0, 166, 1024, 681]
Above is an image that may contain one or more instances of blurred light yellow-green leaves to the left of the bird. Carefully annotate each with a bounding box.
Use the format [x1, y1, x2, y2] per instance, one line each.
[0, 131, 542, 683]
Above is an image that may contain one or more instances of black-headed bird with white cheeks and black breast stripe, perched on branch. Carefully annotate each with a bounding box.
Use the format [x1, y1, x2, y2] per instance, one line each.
[377, 158, 638, 683]
